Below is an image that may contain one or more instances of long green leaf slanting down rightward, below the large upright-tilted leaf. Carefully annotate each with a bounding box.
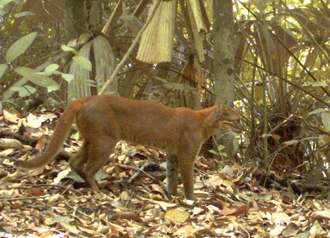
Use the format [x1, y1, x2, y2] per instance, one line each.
[15, 67, 60, 92]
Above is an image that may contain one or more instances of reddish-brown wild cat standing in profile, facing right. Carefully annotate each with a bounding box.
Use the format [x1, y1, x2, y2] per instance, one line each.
[15, 95, 239, 199]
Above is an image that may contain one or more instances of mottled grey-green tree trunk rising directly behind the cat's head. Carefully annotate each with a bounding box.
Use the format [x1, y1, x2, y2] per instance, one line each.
[213, 0, 237, 159]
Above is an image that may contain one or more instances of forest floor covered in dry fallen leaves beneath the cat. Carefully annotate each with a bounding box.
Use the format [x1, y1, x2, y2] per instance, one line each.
[0, 110, 330, 238]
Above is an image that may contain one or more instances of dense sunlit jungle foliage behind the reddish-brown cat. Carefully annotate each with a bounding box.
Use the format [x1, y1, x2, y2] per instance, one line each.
[0, 0, 330, 236]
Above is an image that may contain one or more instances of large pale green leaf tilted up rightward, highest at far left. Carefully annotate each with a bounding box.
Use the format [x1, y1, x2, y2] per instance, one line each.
[6, 32, 37, 62]
